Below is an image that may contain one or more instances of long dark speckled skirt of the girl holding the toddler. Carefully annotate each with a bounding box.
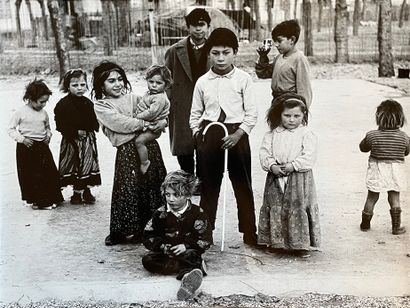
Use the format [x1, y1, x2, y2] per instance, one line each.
[110, 141, 166, 236]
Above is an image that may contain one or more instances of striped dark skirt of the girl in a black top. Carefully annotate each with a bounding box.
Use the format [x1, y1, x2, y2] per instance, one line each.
[58, 132, 101, 189]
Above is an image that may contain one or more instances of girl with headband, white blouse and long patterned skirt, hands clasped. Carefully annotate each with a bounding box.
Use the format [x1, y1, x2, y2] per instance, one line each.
[258, 93, 320, 257]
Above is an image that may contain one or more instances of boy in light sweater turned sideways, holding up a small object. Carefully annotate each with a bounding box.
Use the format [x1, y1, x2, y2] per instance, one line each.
[255, 20, 312, 108]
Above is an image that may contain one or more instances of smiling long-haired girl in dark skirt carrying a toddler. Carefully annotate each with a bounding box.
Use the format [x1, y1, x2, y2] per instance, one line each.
[92, 61, 167, 245]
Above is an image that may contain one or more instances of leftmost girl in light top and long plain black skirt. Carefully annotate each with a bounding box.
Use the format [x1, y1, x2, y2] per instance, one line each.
[8, 80, 64, 210]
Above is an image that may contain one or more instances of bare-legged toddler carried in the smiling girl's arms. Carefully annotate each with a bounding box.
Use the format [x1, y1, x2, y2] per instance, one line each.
[135, 65, 172, 174]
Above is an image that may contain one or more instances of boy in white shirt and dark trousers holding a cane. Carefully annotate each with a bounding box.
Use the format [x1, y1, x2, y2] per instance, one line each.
[190, 28, 257, 246]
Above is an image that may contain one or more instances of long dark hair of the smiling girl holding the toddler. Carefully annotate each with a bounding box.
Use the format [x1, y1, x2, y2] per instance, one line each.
[91, 61, 132, 99]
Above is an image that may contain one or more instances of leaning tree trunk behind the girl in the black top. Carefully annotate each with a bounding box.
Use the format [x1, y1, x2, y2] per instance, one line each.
[47, 0, 70, 82]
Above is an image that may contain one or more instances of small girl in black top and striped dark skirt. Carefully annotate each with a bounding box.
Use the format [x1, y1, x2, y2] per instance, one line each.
[54, 69, 101, 204]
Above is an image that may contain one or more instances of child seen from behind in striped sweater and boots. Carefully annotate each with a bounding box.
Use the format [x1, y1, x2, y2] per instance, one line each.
[360, 99, 410, 235]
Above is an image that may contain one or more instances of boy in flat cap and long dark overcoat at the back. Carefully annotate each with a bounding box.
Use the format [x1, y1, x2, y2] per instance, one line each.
[165, 8, 211, 183]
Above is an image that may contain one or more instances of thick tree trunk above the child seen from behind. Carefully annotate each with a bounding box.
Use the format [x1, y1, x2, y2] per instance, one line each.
[377, 0, 394, 77]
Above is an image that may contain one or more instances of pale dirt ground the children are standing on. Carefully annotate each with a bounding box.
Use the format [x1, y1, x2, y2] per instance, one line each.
[0, 68, 410, 307]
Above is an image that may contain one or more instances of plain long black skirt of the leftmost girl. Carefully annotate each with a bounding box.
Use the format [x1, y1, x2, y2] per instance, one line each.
[16, 141, 64, 206]
